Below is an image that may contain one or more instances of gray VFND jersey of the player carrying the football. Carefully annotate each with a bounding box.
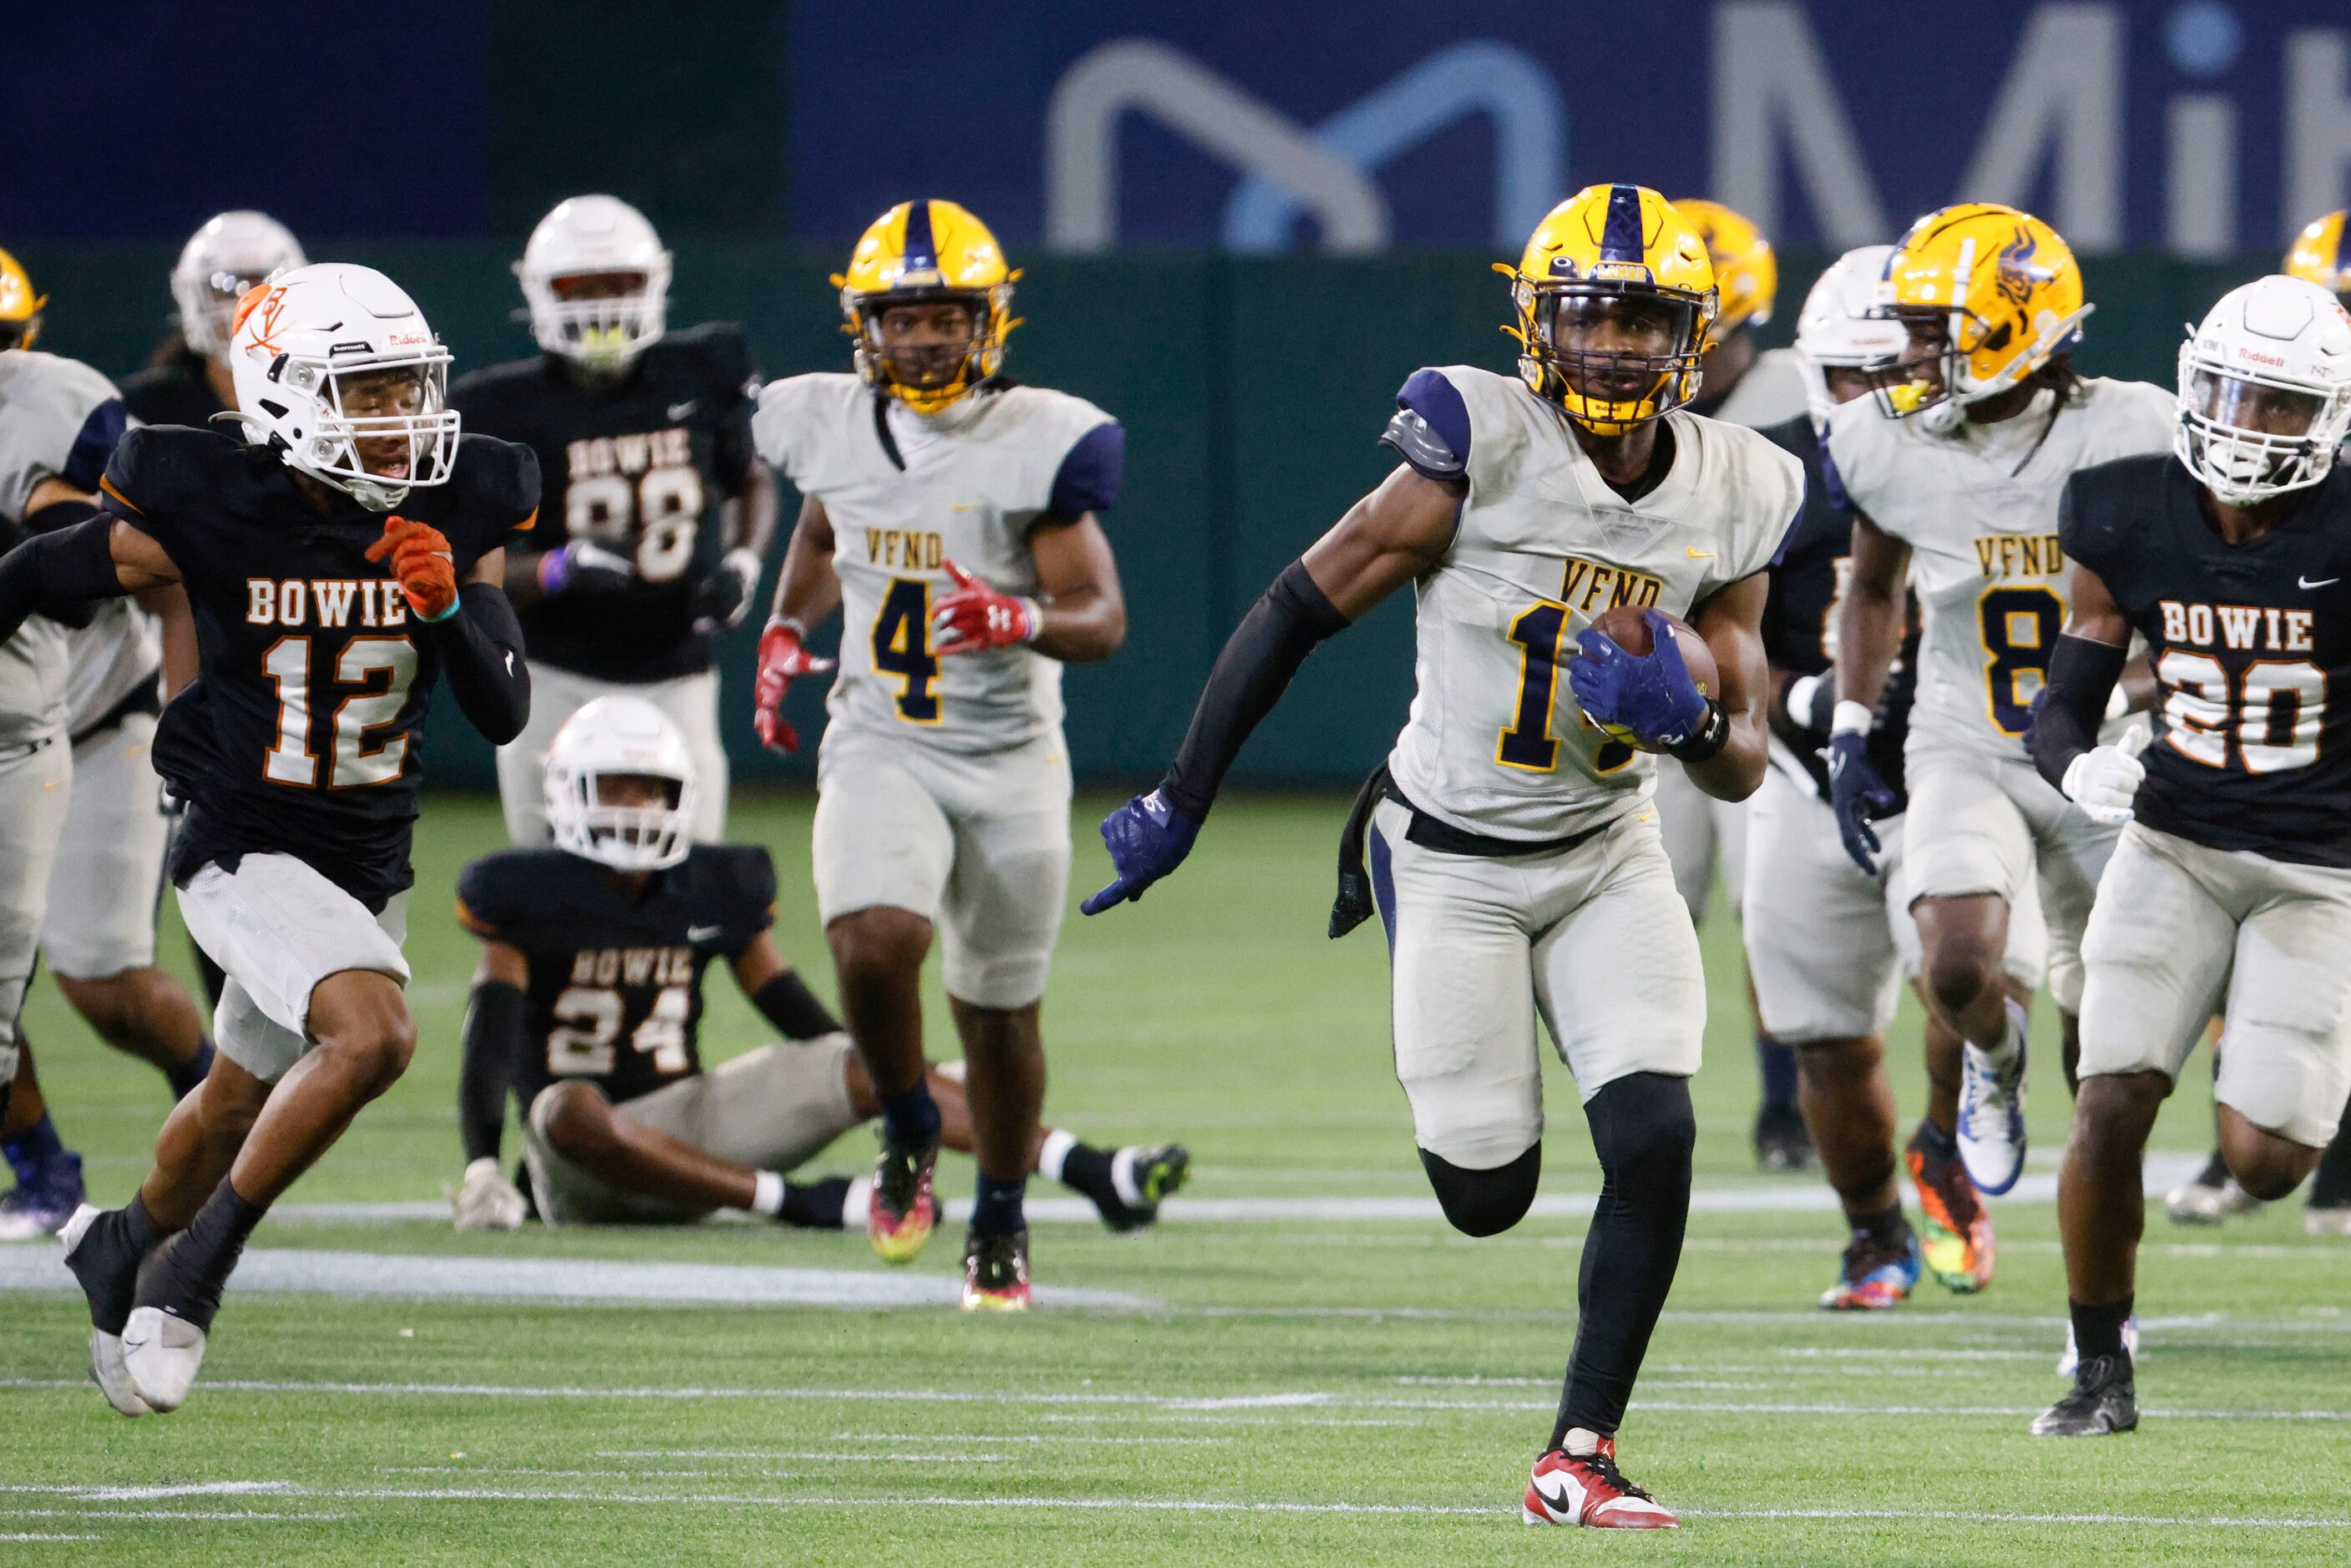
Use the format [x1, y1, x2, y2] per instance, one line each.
[1387, 364, 1803, 839]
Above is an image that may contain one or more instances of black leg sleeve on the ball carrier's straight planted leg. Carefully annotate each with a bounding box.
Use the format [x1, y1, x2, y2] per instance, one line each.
[1552, 1072, 1697, 1448]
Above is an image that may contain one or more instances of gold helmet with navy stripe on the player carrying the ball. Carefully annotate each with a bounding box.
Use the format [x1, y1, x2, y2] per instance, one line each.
[1495, 185, 1716, 435]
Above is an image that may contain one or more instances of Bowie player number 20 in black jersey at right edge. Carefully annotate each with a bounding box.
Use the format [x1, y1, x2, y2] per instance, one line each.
[2034, 277, 2351, 1436]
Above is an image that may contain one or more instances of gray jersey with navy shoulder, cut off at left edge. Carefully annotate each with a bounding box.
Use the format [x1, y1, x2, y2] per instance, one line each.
[0, 348, 122, 747]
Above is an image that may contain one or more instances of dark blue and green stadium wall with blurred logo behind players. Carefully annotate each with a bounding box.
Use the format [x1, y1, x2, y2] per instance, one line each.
[0, 0, 2351, 785]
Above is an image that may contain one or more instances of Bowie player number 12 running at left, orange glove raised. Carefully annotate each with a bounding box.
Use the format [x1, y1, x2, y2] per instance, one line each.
[0, 263, 538, 1415]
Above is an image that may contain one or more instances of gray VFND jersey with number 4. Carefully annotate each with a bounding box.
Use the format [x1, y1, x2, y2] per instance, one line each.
[752, 374, 1112, 752]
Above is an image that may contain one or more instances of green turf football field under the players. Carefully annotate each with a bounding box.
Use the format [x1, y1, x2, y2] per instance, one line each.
[0, 797, 2351, 1565]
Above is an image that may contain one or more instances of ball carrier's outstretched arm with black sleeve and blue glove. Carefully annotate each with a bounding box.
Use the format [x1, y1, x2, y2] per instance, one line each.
[1079, 468, 1467, 914]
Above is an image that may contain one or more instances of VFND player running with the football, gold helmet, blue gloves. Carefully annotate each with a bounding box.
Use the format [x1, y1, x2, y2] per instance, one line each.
[1084, 185, 1803, 1528]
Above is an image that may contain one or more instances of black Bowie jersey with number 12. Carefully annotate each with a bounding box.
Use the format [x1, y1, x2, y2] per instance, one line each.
[101, 426, 538, 910]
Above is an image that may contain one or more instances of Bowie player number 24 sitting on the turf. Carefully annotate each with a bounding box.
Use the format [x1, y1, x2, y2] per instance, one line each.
[453, 695, 1190, 1230]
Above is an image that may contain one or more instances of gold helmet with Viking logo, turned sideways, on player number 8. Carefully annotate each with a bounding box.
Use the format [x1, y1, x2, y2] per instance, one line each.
[1872, 202, 2092, 423]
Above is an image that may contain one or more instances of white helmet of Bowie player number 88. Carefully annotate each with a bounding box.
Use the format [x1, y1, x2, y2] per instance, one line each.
[515, 195, 670, 374]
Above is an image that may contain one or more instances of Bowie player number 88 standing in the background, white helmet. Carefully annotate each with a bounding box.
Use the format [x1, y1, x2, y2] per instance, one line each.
[449, 195, 776, 844]
